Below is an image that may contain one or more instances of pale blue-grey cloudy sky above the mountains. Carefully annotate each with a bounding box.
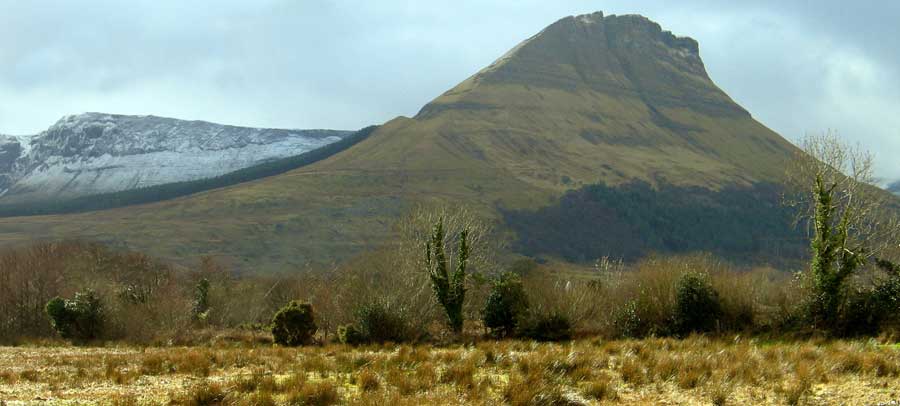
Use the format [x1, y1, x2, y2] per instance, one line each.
[0, 0, 900, 178]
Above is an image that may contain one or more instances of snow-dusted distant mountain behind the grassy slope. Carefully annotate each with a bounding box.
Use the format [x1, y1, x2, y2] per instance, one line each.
[0, 113, 350, 204]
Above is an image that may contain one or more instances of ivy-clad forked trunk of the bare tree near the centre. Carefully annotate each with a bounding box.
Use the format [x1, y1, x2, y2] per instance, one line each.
[425, 219, 469, 333]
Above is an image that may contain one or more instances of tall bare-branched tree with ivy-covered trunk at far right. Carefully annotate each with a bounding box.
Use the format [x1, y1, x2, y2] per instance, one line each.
[788, 132, 900, 328]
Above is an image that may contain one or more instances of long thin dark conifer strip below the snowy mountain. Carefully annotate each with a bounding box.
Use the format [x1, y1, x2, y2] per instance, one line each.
[0, 126, 378, 217]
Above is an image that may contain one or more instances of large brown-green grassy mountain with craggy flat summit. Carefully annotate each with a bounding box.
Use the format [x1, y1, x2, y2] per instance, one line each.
[0, 13, 796, 271]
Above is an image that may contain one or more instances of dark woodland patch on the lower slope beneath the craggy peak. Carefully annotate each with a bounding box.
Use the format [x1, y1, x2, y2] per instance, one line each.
[503, 181, 809, 266]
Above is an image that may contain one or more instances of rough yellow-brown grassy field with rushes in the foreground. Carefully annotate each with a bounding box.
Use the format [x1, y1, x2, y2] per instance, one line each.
[0, 337, 900, 405]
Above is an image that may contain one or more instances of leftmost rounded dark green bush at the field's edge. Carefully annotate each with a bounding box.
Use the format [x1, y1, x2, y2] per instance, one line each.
[44, 290, 105, 341]
